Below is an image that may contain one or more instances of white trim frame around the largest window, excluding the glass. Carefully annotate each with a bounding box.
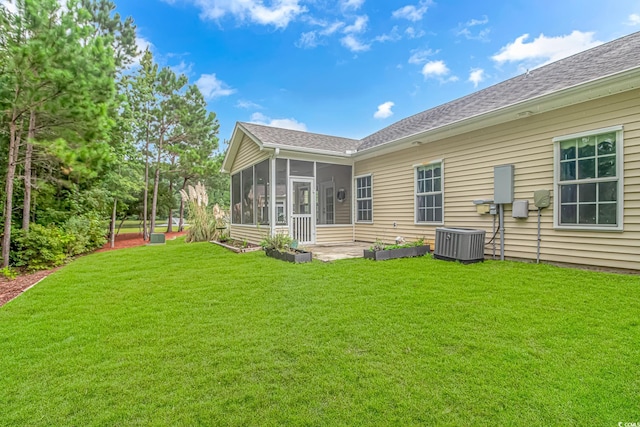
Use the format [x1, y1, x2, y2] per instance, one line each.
[553, 125, 624, 232]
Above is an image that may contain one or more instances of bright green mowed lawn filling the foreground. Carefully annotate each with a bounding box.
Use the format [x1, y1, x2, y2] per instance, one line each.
[0, 239, 640, 426]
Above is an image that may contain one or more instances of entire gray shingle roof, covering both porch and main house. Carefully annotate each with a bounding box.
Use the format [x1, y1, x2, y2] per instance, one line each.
[240, 32, 640, 154]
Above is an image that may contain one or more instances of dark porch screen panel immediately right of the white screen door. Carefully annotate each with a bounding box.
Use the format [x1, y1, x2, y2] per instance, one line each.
[316, 162, 353, 225]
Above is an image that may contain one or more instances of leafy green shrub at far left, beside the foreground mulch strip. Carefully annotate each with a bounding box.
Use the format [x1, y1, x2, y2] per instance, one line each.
[11, 224, 75, 270]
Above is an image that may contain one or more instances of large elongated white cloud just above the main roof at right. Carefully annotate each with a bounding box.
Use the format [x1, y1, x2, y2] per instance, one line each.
[491, 31, 602, 66]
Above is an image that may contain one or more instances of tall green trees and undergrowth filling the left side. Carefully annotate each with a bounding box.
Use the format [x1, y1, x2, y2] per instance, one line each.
[0, 0, 229, 268]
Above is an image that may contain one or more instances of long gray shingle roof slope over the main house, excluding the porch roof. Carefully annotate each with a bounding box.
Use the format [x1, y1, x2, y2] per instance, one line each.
[358, 32, 640, 150]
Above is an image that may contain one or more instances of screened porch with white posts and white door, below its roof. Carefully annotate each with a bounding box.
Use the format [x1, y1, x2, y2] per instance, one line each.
[231, 158, 353, 244]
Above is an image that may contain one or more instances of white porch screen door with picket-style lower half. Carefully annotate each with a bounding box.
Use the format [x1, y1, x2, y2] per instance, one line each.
[289, 178, 316, 244]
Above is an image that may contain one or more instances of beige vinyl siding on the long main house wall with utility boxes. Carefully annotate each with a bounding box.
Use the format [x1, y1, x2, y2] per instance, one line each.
[354, 90, 640, 269]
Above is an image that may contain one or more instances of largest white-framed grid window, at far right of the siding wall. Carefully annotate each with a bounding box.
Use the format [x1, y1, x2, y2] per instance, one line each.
[554, 127, 623, 229]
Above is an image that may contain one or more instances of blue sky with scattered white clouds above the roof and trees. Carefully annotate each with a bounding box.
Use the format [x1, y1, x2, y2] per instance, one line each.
[116, 0, 640, 148]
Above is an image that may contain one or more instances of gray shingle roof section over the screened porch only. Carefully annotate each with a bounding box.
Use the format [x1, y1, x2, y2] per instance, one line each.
[240, 122, 360, 154]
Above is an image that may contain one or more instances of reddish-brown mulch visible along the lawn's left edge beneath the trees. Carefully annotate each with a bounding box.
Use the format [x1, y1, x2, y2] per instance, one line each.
[0, 231, 186, 306]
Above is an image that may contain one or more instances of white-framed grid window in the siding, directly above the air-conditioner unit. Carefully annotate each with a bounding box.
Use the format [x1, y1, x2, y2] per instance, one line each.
[415, 161, 443, 224]
